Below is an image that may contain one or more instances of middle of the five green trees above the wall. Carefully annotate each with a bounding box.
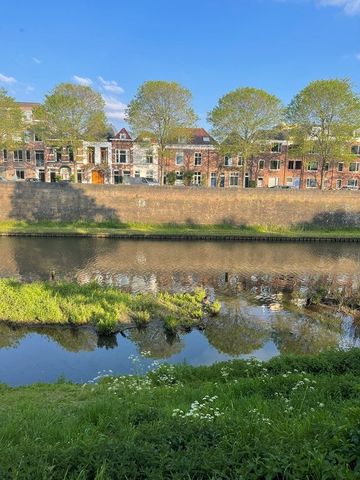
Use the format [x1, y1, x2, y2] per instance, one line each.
[127, 81, 196, 184]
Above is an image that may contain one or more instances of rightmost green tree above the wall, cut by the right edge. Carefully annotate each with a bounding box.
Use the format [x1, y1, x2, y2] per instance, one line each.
[287, 79, 360, 188]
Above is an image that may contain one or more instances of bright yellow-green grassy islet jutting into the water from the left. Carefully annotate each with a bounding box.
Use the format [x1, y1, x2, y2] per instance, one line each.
[0, 279, 220, 334]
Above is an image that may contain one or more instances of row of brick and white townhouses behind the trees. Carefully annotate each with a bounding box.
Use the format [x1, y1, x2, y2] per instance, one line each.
[0, 103, 360, 189]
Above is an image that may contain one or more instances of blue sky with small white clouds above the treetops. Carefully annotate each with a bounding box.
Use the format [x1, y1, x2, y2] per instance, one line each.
[0, 0, 360, 126]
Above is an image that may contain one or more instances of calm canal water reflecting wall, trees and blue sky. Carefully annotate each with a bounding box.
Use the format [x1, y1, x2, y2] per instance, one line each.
[0, 238, 360, 385]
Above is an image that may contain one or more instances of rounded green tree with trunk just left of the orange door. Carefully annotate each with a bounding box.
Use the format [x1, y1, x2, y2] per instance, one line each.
[34, 83, 107, 182]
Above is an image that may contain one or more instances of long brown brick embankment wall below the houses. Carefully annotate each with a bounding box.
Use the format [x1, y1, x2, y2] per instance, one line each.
[0, 182, 360, 227]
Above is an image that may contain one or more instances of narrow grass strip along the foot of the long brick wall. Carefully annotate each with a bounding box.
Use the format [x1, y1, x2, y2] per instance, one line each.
[0, 221, 360, 239]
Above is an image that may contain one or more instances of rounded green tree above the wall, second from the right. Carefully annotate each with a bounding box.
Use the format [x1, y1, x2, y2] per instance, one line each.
[208, 87, 283, 186]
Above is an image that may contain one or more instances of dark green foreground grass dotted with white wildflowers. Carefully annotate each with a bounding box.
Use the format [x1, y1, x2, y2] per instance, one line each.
[0, 350, 360, 480]
